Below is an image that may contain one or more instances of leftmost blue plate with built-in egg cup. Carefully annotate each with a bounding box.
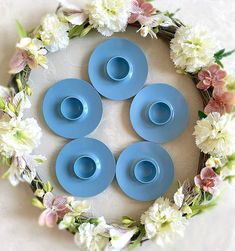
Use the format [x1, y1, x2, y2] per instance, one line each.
[42, 79, 103, 139]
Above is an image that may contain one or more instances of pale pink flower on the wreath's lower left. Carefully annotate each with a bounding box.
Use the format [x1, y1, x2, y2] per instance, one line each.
[38, 192, 70, 227]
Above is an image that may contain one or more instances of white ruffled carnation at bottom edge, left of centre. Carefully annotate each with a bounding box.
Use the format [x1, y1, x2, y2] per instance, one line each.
[74, 217, 109, 251]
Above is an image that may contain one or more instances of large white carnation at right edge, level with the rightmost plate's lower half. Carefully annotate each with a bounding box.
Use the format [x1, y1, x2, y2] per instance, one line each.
[194, 112, 235, 157]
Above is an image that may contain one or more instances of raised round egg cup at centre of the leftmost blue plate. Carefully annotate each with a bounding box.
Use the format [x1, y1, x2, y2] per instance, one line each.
[60, 96, 88, 120]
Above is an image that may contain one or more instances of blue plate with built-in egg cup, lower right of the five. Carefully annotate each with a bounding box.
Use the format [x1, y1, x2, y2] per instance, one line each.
[116, 141, 174, 201]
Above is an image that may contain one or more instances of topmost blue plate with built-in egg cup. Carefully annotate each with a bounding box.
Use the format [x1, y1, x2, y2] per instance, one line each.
[88, 38, 148, 100]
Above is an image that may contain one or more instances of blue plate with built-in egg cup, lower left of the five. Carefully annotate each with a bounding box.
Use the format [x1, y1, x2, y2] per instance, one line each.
[56, 138, 115, 197]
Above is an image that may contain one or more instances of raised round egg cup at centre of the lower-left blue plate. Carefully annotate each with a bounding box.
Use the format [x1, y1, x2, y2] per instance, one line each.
[73, 155, 100, 180]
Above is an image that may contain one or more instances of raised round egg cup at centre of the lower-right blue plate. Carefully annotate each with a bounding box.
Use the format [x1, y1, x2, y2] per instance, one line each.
[133, 159, 159, 184]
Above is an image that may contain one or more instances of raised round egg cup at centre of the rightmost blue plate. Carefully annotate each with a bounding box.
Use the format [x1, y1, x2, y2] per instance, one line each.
[147, 101, 174, 126]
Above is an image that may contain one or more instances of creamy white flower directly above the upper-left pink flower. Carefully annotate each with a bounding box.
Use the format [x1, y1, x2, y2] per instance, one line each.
[16, 37, 47, 69]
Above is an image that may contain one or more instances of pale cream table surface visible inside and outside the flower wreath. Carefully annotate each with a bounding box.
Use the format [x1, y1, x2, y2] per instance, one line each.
[0, 0, 235, 251]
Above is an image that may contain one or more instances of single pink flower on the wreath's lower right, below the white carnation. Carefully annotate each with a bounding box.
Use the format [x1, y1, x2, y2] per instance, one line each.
[194, 167, 219, 194]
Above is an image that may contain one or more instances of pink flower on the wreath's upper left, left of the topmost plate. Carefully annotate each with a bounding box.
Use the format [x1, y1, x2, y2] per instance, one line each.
[9, 49, 37, 74]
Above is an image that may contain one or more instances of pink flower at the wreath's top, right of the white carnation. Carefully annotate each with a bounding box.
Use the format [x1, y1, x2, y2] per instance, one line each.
[128, 0, 155, 24]
